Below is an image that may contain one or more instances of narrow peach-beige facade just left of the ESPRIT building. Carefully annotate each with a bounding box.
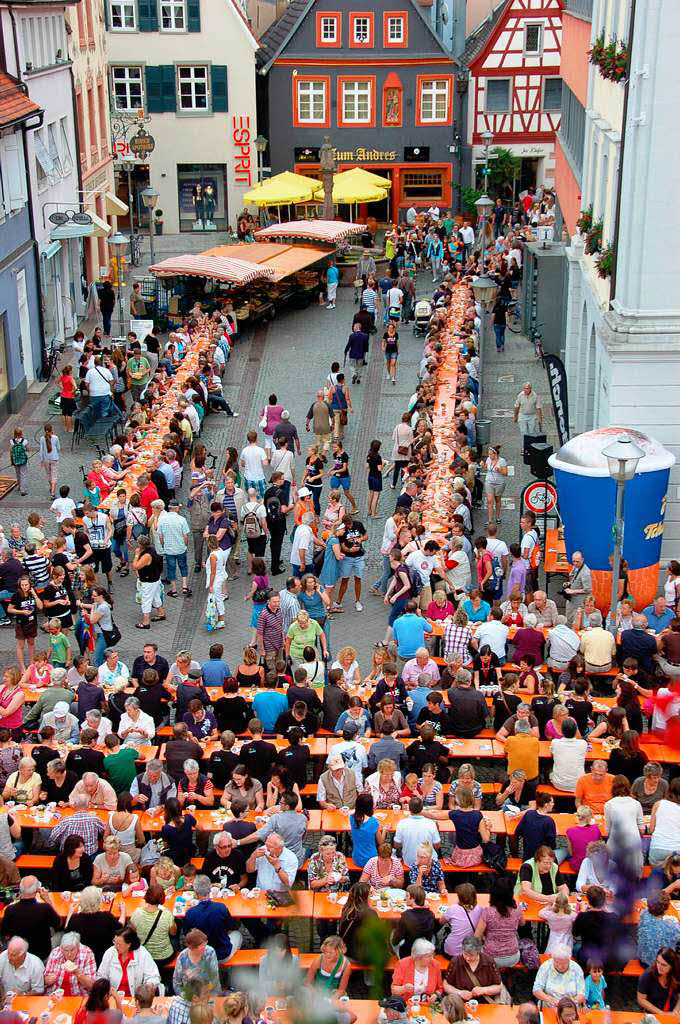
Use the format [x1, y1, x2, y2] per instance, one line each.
[66, 0, 120, 284]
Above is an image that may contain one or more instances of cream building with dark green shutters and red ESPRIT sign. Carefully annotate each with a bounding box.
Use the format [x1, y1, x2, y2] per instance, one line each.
[105, 0, 258, 233]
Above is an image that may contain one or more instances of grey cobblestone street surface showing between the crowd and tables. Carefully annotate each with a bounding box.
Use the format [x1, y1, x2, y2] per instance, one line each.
[0, 264, 554, 671]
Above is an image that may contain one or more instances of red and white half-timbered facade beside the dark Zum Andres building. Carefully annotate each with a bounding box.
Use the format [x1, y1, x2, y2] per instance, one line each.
[468, 0, 562, 186]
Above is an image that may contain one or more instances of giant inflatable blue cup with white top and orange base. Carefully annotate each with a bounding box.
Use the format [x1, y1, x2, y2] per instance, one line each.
[549, 427, 675, 612]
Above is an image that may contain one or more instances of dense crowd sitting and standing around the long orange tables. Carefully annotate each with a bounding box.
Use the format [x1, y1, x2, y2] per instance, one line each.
[0, 199, 680, 1024]
